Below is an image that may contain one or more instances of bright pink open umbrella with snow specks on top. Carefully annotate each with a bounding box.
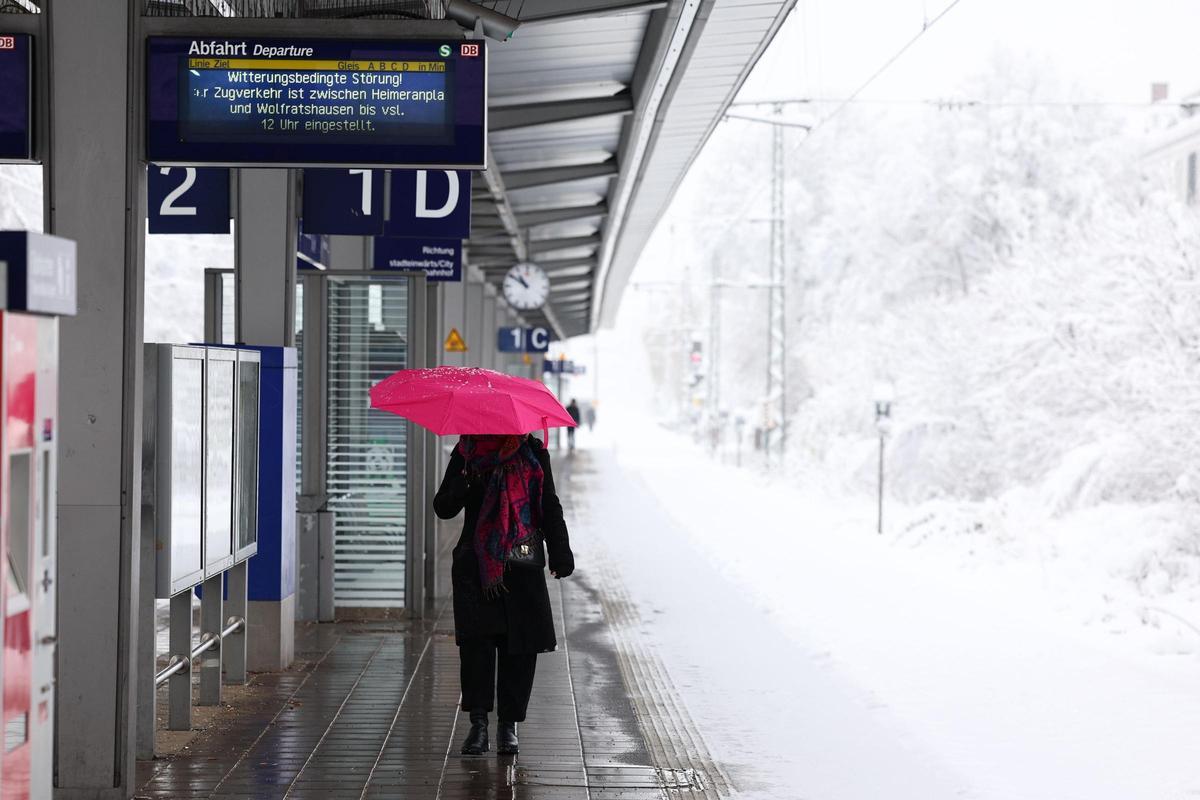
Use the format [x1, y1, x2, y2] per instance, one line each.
[371, 367, 575, 435]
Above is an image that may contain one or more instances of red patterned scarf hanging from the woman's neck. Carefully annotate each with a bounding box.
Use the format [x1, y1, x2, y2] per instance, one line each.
[458, 435, 542, 596]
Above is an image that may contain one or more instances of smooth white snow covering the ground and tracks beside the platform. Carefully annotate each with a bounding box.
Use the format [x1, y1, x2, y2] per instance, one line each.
[568, 417, 1200, 800]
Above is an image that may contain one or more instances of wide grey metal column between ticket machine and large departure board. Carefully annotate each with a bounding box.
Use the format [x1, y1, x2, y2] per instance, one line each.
[45, 0, 145, 800]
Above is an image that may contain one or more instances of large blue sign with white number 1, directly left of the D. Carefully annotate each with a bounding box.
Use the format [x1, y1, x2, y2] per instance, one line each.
[304, 168, 384, 236]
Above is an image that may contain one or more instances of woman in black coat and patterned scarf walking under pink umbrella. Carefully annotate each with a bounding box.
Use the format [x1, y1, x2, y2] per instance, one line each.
[433, 435, 575, 756]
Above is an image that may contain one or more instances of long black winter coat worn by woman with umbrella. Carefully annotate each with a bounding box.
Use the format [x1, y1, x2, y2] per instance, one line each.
[433, 437, 575, 654]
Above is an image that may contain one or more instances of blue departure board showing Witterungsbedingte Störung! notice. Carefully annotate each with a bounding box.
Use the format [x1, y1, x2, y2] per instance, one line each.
[146, 37, 487, 169]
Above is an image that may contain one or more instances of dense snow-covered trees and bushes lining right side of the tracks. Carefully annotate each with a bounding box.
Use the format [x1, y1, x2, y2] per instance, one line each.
[643, 56, 1200, 513]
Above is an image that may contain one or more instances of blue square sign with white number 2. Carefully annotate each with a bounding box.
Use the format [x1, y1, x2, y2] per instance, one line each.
[146, 164, 229, 234]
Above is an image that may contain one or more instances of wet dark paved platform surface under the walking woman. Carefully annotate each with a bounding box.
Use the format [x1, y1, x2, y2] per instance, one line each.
[136, 455, 731, 800]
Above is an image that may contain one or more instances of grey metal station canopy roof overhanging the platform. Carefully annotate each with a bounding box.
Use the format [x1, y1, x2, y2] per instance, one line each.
[93, 0, 796, 337]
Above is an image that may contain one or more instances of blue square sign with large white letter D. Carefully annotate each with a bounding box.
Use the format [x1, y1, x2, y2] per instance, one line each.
[384, 169, 470, 239]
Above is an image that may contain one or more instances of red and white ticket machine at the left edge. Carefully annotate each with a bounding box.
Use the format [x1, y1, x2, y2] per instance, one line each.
[0, 231, 76, 800]
